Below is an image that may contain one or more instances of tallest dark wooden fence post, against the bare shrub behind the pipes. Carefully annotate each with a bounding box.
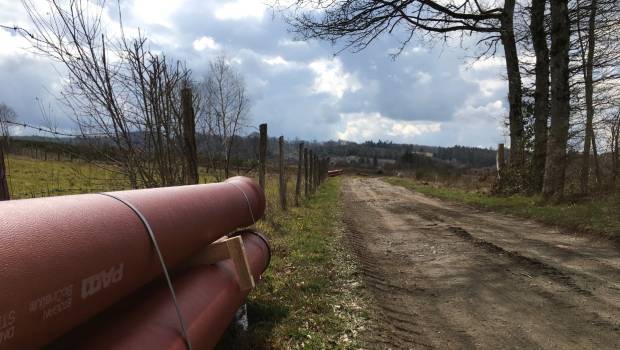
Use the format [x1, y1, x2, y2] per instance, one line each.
[181, 88, 198, 185]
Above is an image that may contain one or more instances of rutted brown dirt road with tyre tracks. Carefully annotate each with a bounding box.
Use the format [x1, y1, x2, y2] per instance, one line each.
[344, 178, 620, 349]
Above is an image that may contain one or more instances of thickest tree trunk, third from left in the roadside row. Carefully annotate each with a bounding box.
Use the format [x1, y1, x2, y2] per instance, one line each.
[543, 0, 570, 200]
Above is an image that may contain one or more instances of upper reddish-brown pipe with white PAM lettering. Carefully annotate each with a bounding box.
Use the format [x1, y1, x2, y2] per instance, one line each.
[0, 177, 265, 350]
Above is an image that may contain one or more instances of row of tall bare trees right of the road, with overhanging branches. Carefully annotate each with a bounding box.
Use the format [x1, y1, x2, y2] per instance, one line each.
[283, 0, 620, 200]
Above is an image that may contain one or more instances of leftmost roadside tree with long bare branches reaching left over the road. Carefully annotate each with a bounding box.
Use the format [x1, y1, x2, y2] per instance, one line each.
[284, 0, 525, 170]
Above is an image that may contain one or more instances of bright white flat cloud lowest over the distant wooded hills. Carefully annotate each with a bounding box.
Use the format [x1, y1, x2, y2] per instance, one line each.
[336, 112, 441, 143]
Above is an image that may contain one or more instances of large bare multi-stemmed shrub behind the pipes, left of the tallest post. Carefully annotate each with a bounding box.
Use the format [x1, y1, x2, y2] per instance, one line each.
[21, 0, 199, 188]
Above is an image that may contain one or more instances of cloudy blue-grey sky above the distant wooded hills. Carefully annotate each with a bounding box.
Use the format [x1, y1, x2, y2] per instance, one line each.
[0, 0, 507, 147]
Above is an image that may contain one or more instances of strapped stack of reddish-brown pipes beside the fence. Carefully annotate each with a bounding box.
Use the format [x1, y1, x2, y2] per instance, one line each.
[0, 177, 270, 350]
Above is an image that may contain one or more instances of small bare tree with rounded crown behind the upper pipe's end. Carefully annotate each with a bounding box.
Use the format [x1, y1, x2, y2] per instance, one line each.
[200, 56, 250, 180]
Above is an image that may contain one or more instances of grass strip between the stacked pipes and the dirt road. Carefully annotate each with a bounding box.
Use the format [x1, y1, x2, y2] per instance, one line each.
[219, 178, 369, 349]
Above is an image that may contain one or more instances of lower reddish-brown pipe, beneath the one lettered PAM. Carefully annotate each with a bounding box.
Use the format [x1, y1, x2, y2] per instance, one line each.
[46, 231, 270, 350]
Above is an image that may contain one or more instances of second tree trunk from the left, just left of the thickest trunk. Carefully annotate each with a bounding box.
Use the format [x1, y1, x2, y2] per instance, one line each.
[530, 0, 549, 192]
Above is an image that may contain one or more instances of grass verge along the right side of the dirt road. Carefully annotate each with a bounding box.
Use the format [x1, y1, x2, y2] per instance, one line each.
[384, 177, 620, 240]
